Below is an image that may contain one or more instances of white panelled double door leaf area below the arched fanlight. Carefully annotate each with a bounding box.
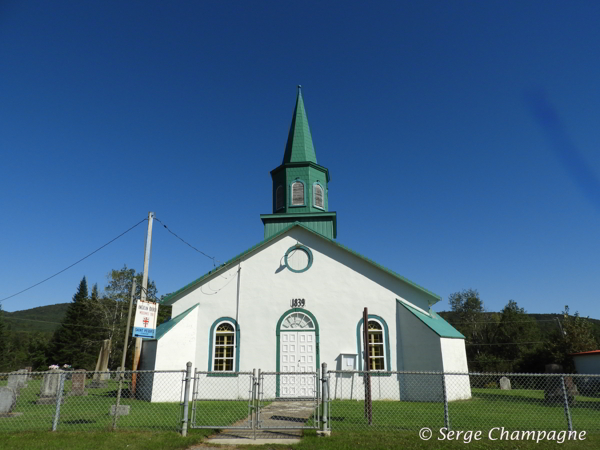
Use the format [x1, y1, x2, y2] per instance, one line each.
[279, 331, 316, 397]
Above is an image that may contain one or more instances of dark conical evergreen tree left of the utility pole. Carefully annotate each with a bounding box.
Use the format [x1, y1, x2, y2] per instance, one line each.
[48, 277, 96, 369]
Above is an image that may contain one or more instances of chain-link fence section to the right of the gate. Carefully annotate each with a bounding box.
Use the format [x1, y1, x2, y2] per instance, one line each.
[326, 371, 600, 431]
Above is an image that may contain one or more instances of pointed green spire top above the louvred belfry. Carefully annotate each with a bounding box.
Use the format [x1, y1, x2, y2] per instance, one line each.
[283, 85, 317, 164]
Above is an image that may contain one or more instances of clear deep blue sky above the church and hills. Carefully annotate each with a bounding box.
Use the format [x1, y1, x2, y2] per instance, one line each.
[0, 1, 600, 318]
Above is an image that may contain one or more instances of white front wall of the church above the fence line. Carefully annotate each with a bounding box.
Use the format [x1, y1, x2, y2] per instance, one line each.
[157, 227, 464, 402]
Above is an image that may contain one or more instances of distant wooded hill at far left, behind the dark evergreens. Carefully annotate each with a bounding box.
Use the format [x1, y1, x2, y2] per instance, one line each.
[3, 303, 69, 333]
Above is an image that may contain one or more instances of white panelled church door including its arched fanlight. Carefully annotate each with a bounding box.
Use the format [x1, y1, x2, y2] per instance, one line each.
[279, 312, 317, 397]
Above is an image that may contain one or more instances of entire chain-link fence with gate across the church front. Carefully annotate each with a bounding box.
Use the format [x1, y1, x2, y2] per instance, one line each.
[0, 364, 600, 434]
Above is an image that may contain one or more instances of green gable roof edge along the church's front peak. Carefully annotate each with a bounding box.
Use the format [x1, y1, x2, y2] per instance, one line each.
[161, 222, 440, 308]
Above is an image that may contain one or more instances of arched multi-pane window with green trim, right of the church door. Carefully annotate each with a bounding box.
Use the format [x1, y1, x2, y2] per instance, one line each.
[356, 314, 392, 371]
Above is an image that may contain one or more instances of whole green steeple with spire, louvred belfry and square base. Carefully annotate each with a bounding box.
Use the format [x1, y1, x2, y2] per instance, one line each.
[260, 86, 337, 239]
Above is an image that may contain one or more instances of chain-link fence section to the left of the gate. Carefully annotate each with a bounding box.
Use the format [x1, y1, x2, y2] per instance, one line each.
[0, 370, 185, 431]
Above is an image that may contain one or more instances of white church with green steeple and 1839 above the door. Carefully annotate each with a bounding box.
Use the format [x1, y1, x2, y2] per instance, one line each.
[140, 89, 471, 401]
